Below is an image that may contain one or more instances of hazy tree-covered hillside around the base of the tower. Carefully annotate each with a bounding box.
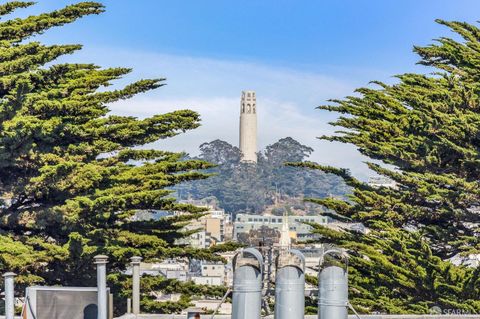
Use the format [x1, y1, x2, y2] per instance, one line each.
[175, 137, 348, 214]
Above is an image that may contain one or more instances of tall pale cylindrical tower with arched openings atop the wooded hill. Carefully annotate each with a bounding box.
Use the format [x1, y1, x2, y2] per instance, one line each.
[240, 91, 257, 163]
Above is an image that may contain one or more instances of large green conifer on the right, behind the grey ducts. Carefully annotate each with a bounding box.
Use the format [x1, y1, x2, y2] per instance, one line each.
[294, 20, 480, 313]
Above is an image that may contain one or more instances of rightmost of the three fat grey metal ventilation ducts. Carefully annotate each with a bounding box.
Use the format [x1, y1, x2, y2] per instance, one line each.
[318, 249, 348, 319]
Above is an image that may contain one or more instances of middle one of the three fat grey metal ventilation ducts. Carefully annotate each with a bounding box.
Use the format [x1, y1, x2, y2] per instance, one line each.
[275, 249, 305, 319]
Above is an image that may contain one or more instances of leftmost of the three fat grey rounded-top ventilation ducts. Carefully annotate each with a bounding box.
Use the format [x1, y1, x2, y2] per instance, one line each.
[232, 248, 263, 319]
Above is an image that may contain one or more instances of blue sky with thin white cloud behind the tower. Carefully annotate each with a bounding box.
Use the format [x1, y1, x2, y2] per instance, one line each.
[13, 0, 480, 178]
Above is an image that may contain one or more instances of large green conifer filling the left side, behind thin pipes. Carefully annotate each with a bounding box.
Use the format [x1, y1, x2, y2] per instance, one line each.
[0, 1, 229, 311]
